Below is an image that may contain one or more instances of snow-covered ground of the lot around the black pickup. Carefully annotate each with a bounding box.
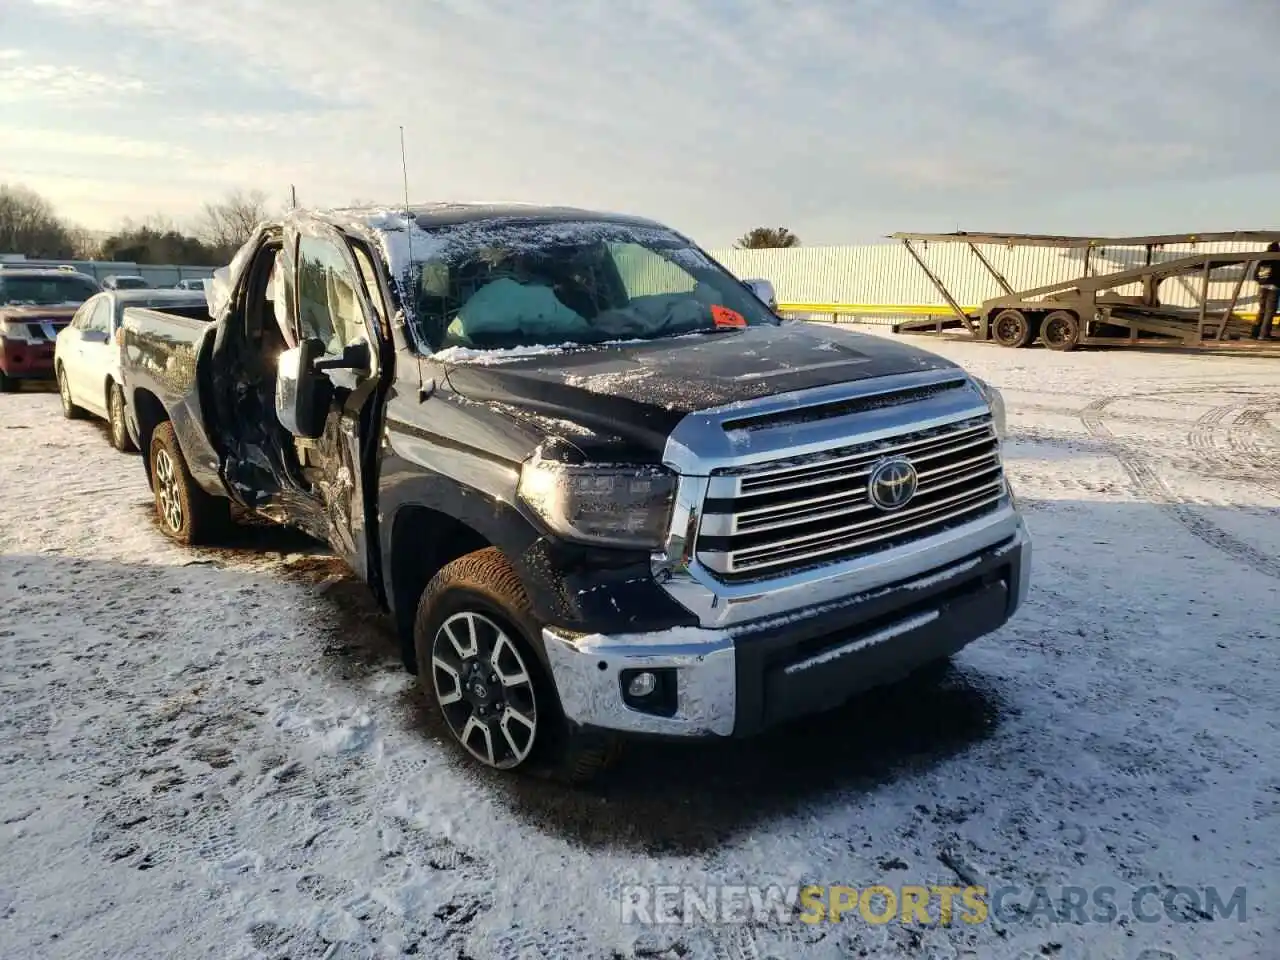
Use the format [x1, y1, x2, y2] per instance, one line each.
[0, 340, 1280, 960]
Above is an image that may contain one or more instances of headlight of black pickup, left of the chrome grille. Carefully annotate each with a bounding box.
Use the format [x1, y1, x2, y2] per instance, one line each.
[520, 458, 676, 549]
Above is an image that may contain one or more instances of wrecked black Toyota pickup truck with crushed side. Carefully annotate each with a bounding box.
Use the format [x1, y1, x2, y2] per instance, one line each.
[123, 205, 1030, 778]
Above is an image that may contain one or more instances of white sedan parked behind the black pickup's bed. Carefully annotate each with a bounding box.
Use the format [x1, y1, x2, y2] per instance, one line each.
[54, 289, 209, 452]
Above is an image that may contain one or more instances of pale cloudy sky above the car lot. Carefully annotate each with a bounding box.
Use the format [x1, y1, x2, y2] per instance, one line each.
[0, 0, 1280, 247]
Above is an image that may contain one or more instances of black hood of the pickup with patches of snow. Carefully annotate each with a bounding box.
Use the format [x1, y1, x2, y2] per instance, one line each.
[445, 321, 955, 457]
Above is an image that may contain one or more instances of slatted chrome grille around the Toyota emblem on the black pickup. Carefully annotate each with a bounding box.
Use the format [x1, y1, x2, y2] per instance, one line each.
[696, 416, 1007, 581]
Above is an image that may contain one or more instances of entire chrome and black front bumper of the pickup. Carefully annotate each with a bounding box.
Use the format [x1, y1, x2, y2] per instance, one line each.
[543, 520, 1032, 737]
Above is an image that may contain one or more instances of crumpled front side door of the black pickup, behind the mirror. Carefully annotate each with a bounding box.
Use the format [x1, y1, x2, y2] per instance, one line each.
[285, 227, 383, 580]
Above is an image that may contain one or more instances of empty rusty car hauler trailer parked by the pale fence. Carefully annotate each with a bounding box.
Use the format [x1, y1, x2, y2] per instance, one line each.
[892, 230, 1280, 349]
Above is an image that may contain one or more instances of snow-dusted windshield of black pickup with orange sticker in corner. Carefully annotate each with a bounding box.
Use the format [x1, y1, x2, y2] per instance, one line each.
[366, 210, 777, 353]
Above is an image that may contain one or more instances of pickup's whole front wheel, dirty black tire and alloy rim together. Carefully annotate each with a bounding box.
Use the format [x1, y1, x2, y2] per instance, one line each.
[413, 547, 617, 785]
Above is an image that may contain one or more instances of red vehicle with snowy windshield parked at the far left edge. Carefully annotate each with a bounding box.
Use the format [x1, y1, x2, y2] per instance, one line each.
[0, 265, 100, 393]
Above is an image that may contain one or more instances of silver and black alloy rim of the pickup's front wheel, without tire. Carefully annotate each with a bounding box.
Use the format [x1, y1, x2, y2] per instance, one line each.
[431, 611, 538, 769]
